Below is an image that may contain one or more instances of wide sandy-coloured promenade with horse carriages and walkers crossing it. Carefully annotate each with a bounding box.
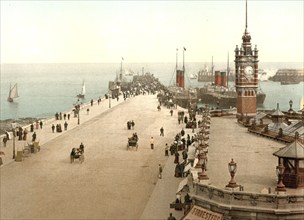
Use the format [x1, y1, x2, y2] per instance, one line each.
[0, 95, 183, 219]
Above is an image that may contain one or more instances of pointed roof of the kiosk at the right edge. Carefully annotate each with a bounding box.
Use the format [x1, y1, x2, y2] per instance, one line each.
[273, 139, 304, 159]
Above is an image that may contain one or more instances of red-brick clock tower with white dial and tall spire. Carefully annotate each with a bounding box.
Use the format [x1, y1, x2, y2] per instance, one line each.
[234, 0, 259, 119]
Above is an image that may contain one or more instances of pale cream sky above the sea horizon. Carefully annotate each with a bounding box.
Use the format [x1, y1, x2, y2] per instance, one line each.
[0, 0, 304, 63]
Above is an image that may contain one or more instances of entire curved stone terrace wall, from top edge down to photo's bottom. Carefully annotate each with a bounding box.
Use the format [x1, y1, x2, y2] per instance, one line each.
[191, 183, 304, 219]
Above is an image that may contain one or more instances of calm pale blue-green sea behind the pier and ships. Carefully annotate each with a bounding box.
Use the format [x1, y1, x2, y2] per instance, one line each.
[0, 62, 304, 120]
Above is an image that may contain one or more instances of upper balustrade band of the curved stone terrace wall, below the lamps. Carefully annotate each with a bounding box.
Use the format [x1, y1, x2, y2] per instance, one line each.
[191, 183, 304, 214]
